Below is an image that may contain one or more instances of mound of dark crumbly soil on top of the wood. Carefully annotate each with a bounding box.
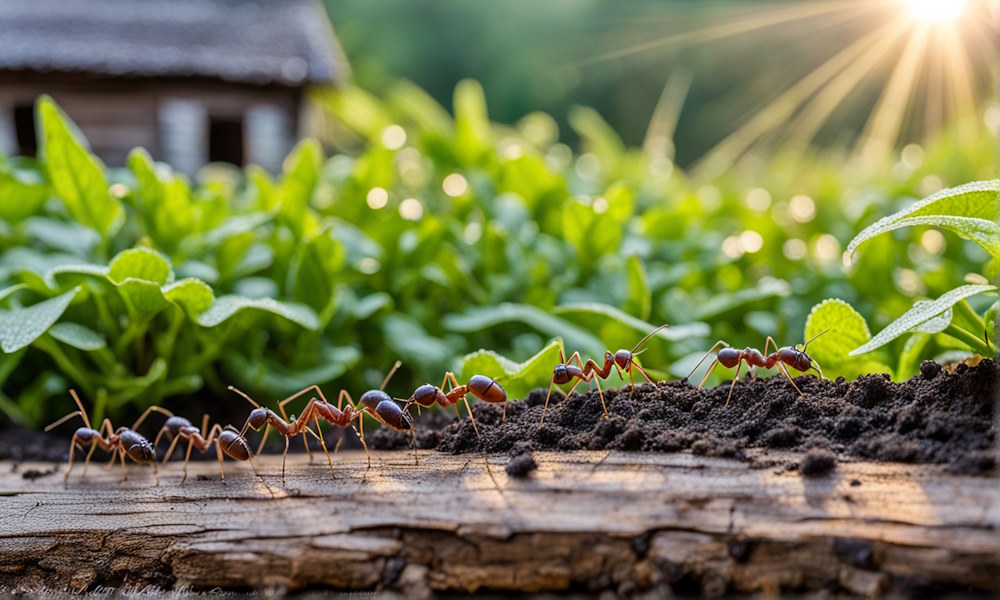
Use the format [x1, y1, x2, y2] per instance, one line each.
[378, 360, 1000, 474]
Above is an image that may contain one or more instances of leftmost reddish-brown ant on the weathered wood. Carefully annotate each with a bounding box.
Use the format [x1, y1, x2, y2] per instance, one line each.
[45, 390, 167, 485]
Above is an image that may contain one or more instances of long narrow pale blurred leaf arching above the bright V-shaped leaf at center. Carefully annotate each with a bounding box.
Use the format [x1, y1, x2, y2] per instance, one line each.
[443, 302, 605, 356]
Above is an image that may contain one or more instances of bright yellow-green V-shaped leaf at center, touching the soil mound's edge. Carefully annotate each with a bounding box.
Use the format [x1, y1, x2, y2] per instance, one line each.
[460, 338, 563, 400]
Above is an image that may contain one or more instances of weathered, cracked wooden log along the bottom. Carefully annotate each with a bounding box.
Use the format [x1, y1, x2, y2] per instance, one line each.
[0, 452, 1000, 595]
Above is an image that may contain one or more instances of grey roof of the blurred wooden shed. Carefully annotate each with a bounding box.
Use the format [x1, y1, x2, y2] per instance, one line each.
[0, 0, 348, 86]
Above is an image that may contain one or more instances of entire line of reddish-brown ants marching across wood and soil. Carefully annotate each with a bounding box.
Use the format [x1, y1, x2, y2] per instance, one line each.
[45, 325, 826, 489]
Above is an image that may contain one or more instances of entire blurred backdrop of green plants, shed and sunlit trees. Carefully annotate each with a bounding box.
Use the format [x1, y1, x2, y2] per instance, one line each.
[0, 0, 1000, 425]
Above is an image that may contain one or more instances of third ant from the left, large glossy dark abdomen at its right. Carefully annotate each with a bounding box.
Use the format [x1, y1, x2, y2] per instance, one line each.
[274, 360, 416, 469]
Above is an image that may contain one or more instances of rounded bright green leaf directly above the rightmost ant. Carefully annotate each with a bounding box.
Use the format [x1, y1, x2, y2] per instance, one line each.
[804, 298, 872, 367]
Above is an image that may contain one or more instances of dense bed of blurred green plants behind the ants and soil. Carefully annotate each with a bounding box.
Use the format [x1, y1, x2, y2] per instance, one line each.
[0, 81, 996, 425]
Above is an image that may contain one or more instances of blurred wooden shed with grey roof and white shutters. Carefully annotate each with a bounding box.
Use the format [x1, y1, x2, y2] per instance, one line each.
[0, 0, 348, 174]
